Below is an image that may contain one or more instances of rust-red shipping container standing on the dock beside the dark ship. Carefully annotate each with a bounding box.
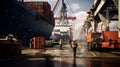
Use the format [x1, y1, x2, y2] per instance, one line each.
[33, 36, 45, 49]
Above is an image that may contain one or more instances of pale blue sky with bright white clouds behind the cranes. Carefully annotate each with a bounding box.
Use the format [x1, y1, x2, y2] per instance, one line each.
[24, 0, 94, 39]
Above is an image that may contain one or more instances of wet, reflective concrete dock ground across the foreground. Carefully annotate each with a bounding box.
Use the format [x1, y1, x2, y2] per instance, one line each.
[0, 43, 120, 67]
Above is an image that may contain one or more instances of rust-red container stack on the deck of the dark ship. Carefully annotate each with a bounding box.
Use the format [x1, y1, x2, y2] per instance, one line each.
[24, 1, 55, 25]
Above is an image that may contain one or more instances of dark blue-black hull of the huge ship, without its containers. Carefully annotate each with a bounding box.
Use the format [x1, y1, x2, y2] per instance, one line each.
[0, 0, 54, 44]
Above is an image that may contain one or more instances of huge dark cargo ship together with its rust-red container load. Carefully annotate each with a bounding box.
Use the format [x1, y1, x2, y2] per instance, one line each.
[0, 0, 55, 46]
